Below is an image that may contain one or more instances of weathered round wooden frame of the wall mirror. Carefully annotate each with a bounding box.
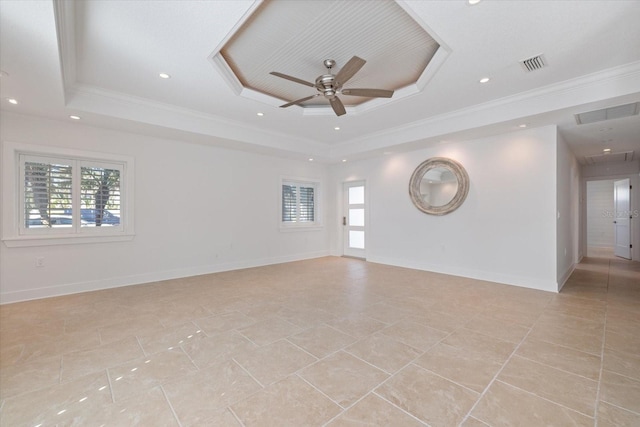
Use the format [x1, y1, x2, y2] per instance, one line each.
[409, 157, 469, 215]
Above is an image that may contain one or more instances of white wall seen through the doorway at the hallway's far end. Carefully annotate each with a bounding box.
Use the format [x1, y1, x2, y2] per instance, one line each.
[586, 179, 615, 249]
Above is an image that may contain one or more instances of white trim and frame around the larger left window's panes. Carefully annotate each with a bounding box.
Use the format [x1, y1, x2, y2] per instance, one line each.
[1, 141, 135, 247]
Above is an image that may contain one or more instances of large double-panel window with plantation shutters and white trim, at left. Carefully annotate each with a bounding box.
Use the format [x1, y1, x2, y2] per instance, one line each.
[2, 144, 133, 246]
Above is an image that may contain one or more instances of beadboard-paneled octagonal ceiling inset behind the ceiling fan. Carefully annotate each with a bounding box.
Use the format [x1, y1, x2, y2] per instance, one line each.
[220, 0, 440, 107]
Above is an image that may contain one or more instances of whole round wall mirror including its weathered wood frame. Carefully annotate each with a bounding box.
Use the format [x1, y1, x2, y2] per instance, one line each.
[409, 157, 469, 215]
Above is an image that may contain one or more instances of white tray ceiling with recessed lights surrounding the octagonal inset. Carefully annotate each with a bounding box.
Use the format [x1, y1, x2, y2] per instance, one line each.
[0, 0, 640, 162]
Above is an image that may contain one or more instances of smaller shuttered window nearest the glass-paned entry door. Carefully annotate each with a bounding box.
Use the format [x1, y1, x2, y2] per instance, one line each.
[281, 180, 319, 227]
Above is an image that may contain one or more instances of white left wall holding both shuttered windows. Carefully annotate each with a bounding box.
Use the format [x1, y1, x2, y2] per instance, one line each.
[0, 113, 332, 303]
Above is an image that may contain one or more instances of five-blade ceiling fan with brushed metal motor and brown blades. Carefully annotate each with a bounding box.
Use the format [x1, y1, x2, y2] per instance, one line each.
[269, 56, 393, 116]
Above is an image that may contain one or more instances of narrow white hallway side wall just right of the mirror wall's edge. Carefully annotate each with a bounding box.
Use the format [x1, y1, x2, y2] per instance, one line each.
[556, 134, 580, 288]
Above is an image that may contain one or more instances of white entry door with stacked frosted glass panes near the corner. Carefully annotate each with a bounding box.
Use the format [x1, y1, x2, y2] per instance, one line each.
[342, 181, 367, 258]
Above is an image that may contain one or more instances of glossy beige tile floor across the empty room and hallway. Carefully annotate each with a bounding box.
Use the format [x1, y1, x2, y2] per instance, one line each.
[0, 257, 640, 427]
